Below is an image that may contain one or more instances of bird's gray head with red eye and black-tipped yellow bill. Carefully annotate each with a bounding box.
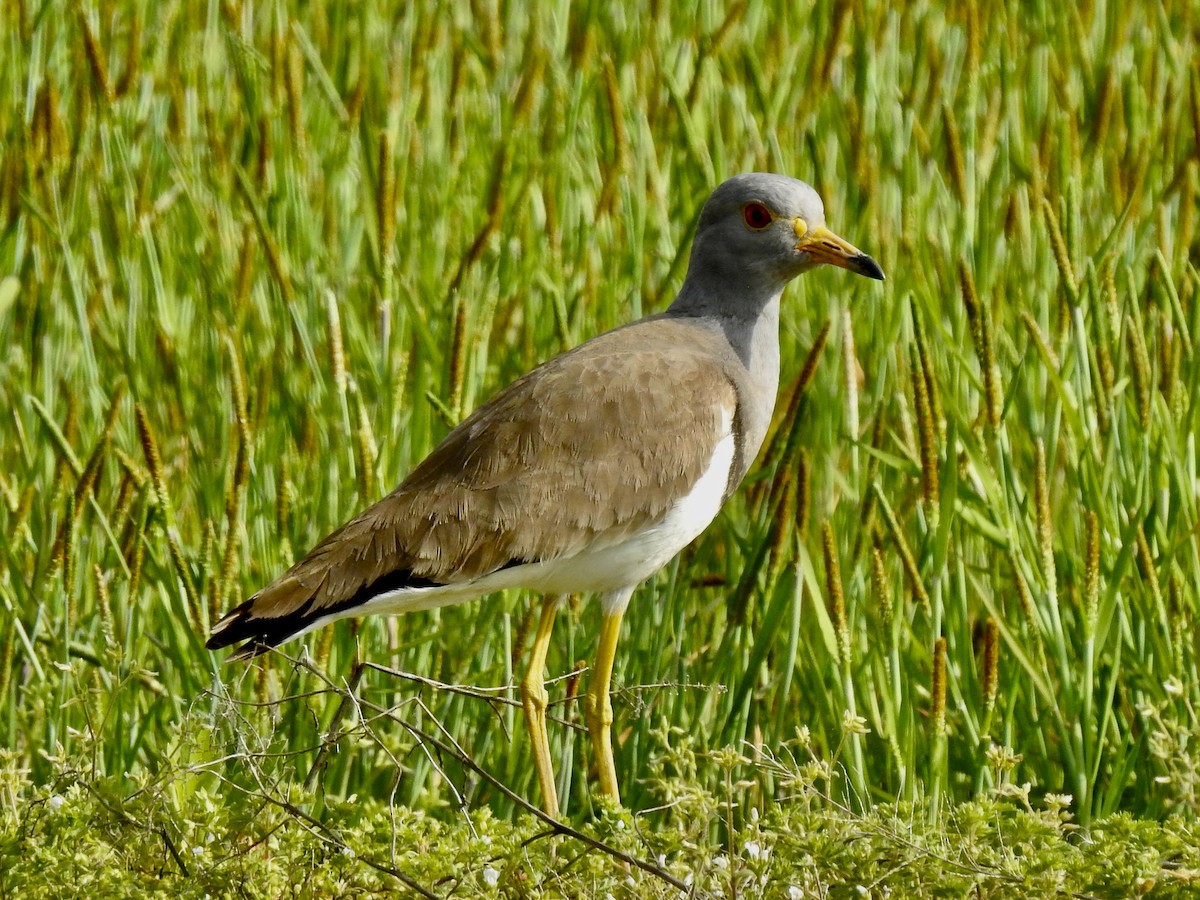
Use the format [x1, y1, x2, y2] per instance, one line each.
[676, 173, 883, 312]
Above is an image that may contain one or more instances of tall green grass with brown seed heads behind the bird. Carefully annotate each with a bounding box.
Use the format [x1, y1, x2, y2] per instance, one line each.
[0, 0, 1200, 895]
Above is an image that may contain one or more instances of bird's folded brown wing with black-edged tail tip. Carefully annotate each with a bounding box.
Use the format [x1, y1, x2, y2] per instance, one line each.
[209, 318, 737, 647]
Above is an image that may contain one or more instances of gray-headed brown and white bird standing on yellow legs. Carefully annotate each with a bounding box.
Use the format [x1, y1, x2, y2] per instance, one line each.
[206, 173, 884, 818]
